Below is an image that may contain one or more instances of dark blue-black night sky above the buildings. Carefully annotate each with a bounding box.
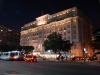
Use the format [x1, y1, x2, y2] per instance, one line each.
[0, 0, 100, 30]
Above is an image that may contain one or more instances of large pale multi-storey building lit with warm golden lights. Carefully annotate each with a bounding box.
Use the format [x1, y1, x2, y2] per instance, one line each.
[20, 7, 92, 56]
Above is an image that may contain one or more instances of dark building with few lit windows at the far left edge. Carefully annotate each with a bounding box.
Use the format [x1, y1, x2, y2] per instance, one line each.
[0, 25, 20, 45]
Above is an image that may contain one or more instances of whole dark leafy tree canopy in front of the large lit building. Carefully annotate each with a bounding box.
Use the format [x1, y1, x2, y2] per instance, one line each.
[43, 32, 72, 53]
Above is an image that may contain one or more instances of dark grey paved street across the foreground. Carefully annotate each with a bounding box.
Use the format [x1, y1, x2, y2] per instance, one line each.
[0, 60, 100, 75]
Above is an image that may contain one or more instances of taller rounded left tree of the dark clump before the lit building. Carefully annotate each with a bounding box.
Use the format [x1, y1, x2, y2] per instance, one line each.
[43, 32, 63, 53]
